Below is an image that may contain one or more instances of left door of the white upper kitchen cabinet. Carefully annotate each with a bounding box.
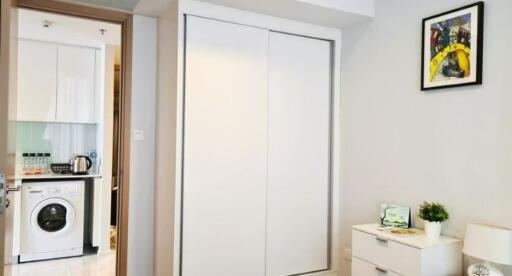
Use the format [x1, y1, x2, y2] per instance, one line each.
[16, 40, 57, 122]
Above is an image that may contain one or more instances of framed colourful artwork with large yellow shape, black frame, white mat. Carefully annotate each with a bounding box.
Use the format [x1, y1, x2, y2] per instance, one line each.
[421, 2, 484, 91]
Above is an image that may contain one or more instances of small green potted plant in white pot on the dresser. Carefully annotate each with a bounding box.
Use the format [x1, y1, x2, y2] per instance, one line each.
[418, 201, 450, 239]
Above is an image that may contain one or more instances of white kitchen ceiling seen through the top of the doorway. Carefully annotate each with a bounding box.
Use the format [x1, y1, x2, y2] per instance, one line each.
[18, 9, 121, 47]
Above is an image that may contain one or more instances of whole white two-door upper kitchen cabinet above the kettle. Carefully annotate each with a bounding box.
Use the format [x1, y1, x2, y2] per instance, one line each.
[17, 39, 101, 123]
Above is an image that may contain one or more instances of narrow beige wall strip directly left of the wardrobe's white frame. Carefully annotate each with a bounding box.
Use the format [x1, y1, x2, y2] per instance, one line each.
[154, 1, 178, 275]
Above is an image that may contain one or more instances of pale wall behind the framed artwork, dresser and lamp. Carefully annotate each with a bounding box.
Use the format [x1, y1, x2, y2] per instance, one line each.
[341, 0, 512, 275]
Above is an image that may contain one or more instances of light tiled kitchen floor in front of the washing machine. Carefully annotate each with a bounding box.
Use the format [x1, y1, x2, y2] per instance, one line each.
[4, 250, 116, 276]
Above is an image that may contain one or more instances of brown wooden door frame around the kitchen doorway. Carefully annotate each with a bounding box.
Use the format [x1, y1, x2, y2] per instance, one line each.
[16, 0, 133, 276]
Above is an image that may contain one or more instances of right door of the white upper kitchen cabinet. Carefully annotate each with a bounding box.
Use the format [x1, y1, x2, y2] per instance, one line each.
[57, 45, 96, 123]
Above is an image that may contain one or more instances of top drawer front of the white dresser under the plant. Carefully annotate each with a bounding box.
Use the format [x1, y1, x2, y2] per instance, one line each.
[352, 230, 421, 276]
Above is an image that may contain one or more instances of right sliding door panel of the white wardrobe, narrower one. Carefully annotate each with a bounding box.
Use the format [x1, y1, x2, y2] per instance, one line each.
[267, 32, 331, 276]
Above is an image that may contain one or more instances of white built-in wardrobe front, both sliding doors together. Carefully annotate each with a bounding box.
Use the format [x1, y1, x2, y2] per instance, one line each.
[180, 16, 332, 276]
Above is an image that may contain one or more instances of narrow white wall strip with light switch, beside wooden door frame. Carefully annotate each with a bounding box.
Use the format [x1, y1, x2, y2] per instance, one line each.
[128, 15, 157, 276]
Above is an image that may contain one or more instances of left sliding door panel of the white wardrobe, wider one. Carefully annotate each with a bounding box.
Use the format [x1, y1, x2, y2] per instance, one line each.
[181, 16, 268, 276]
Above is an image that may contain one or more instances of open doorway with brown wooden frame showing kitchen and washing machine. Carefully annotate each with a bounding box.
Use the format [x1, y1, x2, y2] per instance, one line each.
[2, 0, 132, 275]
